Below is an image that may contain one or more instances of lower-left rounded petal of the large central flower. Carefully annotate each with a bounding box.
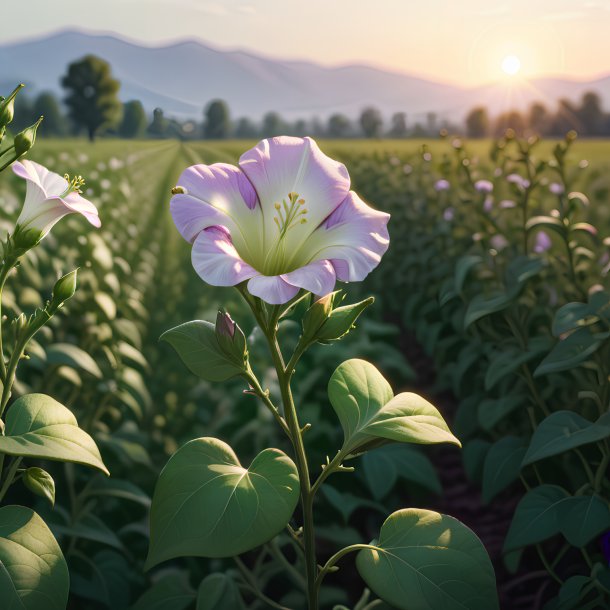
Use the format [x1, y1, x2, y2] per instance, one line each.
[191, 226, 258, 286]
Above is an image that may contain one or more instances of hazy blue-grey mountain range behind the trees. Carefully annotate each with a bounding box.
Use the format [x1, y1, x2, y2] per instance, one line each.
[0, 31, 610, 123]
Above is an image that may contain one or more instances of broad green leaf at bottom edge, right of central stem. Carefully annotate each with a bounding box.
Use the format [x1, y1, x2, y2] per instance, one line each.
[356, 508, 499, 610]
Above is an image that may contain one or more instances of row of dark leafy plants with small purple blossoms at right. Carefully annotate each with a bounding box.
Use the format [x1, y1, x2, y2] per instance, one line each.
[354, 131, 610, 610]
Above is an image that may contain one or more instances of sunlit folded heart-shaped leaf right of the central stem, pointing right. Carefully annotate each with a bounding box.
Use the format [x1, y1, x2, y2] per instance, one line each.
[328, 359, 460, 453]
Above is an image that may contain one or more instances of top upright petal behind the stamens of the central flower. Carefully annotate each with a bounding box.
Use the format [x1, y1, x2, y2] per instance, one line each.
[239, 136, 350, 249]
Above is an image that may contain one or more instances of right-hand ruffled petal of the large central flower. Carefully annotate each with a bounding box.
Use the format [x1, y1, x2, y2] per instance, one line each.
[305, 191, 390, 282]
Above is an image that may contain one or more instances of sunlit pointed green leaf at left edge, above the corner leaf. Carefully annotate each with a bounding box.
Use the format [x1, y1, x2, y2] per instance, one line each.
[0, 394, 110, 474]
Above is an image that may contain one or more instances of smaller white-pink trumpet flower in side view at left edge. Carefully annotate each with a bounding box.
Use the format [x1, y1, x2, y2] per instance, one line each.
[12, 160, 101, 239]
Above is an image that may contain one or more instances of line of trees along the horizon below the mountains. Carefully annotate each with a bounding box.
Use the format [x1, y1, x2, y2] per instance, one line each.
[13, 55, 610, 141]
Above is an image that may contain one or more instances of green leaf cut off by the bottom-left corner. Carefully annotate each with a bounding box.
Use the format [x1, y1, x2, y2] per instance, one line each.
[0, 506, 70, 610]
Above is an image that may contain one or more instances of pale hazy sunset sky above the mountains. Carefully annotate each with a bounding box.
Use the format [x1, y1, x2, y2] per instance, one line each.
[0, 0, 610, 85]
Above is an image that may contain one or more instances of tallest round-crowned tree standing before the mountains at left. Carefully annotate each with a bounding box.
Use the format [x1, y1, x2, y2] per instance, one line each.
[61, 55, 123, 142]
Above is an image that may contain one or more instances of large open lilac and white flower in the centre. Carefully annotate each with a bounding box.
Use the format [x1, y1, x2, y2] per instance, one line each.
[170, 136, 390, 304]
